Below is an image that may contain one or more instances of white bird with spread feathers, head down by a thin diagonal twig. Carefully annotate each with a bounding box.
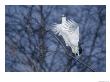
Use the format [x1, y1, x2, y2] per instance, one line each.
[52, 16, 79, 55]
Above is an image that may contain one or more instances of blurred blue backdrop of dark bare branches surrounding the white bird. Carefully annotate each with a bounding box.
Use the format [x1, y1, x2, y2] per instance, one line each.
[5, 5, 106, 72]
